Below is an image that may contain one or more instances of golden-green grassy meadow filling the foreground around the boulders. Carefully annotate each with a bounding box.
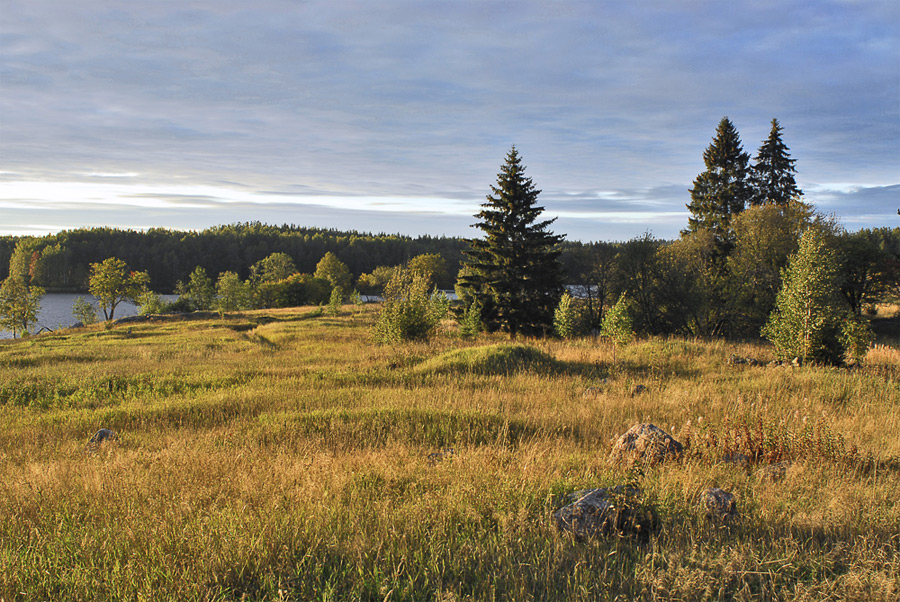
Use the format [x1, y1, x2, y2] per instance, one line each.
[0, 308, 900, 602]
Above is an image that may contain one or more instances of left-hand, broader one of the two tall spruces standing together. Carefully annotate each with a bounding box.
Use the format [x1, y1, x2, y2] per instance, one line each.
[685, 117, 753, 249]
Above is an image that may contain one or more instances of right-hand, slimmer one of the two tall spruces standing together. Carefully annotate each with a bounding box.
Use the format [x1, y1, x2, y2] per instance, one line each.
[750, 119, 803, 207]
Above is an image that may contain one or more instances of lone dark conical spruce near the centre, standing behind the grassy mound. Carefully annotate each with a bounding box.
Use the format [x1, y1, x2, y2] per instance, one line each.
[459, 146, 563, 336]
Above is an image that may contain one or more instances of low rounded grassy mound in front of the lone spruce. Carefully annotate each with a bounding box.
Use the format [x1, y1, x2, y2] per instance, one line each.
[416, 343, 557, 375]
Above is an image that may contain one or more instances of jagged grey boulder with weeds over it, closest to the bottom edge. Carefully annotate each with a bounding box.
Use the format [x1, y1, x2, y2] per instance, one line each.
[553, 485, 656, 538]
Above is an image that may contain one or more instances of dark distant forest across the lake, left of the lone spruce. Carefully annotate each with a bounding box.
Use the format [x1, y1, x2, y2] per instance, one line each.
[0, 222, 474, 293]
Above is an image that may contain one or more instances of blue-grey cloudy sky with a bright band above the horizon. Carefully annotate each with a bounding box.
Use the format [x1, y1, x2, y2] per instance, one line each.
[0, 0, 900, 241]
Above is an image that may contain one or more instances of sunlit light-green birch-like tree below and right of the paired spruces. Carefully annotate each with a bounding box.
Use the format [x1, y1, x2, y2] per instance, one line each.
[762, 228, 847, 364]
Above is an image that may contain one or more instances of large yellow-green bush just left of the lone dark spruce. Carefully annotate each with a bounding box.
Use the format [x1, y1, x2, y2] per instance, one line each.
[374, 268, 450, 343]
